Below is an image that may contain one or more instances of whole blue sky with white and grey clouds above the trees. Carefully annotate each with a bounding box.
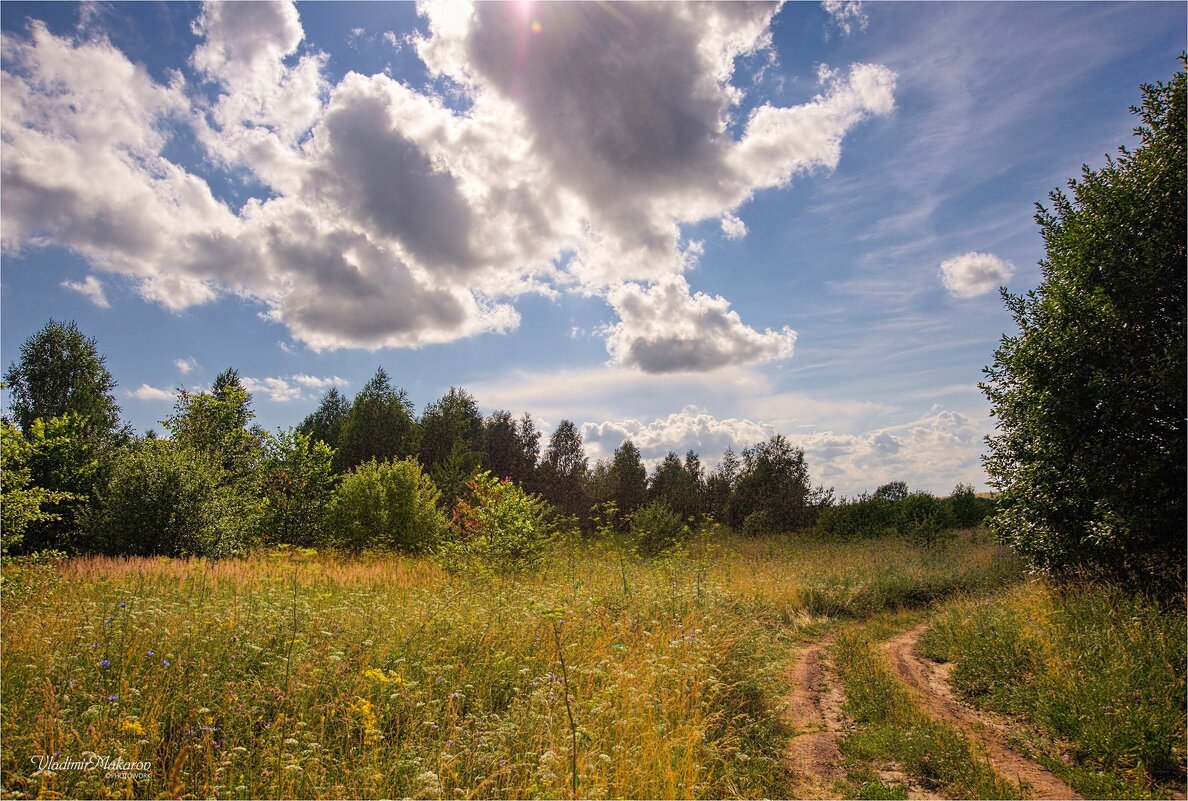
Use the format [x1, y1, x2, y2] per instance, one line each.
[0, 0, 1188, 496]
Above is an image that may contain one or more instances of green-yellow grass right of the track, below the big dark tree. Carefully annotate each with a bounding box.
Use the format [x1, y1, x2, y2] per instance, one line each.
[921, 582, 1188, 797]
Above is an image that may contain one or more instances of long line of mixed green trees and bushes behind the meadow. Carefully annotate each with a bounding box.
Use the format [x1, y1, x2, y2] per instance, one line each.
[4, 320, 980, 556]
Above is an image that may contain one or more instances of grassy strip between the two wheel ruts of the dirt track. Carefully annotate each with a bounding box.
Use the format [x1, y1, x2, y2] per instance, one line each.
[832, 622, 1023, 799]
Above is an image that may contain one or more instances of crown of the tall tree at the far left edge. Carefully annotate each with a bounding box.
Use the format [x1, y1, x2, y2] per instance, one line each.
[5, 320, 120, 435]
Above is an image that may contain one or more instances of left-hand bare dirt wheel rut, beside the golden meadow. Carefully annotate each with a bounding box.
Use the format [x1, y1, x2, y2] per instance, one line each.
[785, 635, 846, 799]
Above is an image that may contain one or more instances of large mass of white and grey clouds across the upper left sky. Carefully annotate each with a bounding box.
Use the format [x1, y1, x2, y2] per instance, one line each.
[0, 0, 895, 356]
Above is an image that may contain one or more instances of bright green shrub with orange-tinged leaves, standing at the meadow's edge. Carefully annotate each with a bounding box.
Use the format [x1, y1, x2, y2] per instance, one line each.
[441, 472, 552, 572]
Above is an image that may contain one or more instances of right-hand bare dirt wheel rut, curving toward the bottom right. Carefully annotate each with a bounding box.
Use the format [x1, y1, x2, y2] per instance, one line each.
[883, 624, 1081, 799]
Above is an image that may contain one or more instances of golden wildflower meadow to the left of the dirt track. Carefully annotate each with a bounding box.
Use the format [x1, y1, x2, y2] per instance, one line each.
[0, 530, 1017, 799]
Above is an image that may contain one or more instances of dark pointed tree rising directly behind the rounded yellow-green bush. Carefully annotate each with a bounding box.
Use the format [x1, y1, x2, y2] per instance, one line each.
[334, 367, 417, 473]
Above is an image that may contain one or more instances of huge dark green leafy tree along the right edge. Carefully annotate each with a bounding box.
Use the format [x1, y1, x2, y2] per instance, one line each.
[981, 57, 1188, 591]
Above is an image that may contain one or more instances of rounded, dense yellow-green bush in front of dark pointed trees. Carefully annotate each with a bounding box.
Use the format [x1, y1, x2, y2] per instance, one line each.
[327, 459, 446, 551]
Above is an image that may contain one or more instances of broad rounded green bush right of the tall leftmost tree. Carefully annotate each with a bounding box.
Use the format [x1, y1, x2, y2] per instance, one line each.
[83, 440, 263, 557]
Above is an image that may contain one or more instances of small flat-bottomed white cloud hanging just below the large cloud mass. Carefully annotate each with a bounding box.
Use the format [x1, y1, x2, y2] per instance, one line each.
[606, 276, 796, 373]
